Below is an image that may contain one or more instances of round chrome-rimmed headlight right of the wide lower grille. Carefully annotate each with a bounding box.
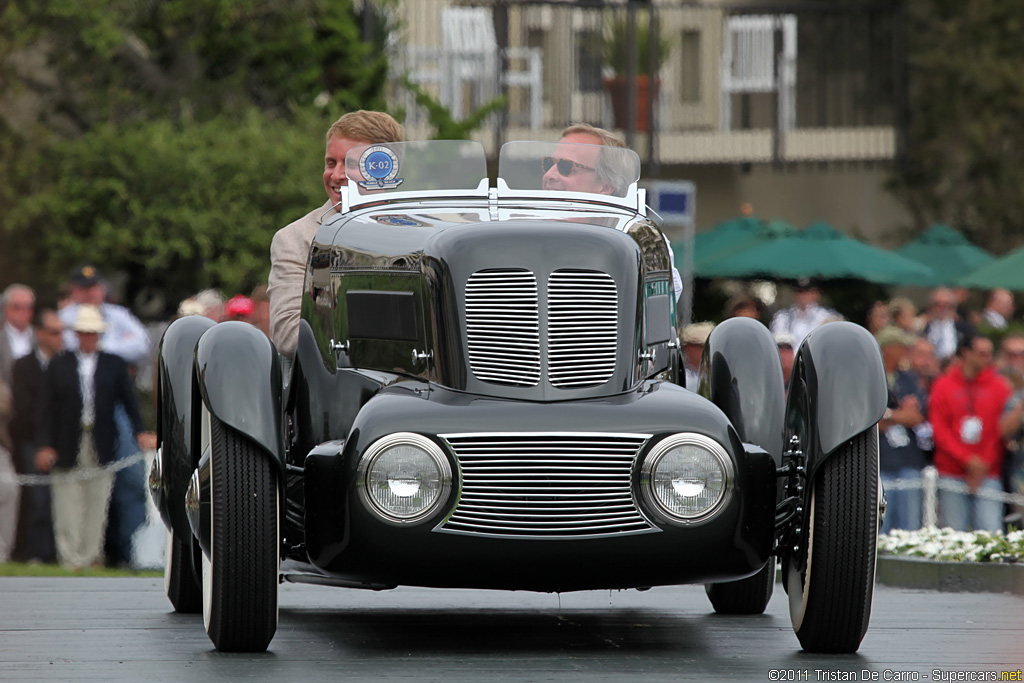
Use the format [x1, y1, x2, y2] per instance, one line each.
[642, 434, 732, 522]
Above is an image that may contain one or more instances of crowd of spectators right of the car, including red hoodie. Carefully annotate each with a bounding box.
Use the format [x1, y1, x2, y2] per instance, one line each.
[682, 280, 1024, 531]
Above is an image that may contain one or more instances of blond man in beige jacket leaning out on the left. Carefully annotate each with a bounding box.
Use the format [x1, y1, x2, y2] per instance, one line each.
[266, 110, 404, 356]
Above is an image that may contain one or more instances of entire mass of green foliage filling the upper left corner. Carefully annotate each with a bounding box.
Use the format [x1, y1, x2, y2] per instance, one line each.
[0, 0, 387, 313]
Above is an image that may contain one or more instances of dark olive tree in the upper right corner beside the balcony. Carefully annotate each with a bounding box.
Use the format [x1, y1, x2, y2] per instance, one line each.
[891, 0, 1024, 253]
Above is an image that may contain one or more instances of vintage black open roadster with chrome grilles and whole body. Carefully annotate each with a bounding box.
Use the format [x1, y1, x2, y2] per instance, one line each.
[150, 141, 887, 652]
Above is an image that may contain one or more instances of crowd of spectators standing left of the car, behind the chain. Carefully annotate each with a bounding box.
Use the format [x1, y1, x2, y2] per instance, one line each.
[0, 265, 269, 569]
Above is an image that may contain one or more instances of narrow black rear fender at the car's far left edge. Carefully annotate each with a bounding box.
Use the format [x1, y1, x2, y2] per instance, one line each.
[150, 315, 214, 538]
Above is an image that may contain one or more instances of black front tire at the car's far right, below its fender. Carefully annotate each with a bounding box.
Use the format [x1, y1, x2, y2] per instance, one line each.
[783, 427, 879, 652]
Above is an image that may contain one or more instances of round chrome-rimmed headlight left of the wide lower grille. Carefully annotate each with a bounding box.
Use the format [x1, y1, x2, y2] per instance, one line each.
[359, 432, 452, 522]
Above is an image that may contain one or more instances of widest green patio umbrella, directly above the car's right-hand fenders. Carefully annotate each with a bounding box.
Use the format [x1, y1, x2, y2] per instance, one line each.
[700, 222, 935, 285]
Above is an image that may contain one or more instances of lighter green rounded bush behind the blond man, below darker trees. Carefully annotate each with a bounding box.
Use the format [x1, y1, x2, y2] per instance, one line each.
[0, 109, 325, 304]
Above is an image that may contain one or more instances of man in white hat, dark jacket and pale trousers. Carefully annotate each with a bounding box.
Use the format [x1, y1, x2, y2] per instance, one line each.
[36, 304, 157, 569]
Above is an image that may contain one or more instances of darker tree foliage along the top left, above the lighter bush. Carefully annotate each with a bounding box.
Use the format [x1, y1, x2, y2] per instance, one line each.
[0, 0, 387, 131]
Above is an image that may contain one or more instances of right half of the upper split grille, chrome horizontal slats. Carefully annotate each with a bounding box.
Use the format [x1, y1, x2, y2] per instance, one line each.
[548, 270, 618, 388]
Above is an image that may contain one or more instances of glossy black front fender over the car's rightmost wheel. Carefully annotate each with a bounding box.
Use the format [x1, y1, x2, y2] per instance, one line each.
[785, 322, 889, 476]
